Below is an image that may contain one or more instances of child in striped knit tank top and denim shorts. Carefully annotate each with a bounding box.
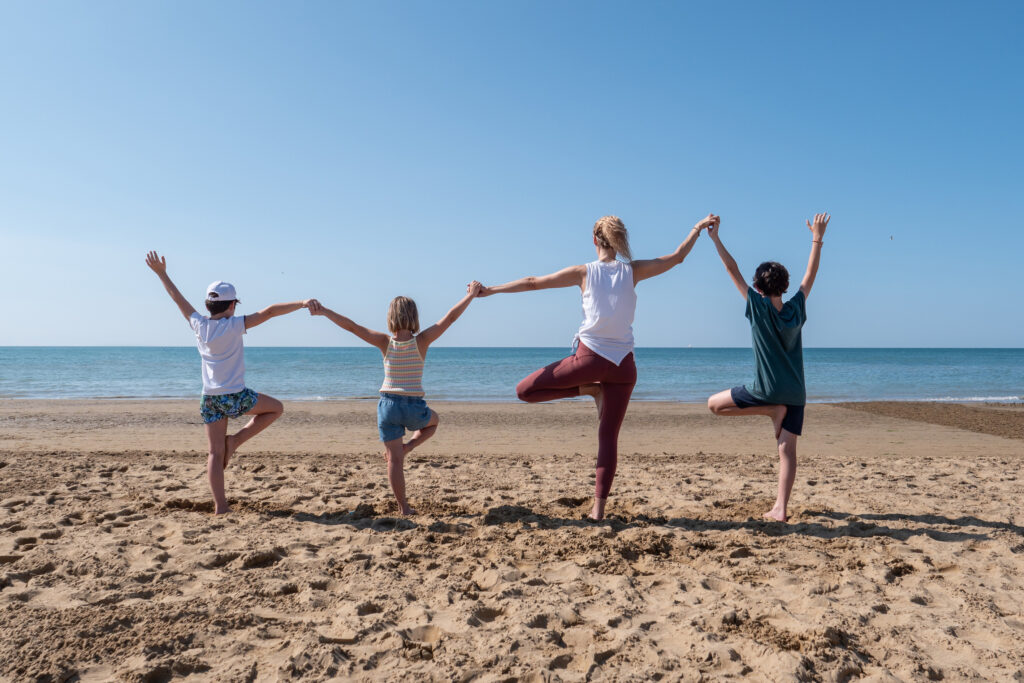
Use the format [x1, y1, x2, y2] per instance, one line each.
[309, 282, 480, 515]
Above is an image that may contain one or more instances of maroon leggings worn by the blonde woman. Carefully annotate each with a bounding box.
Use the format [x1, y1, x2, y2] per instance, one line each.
[515, 343, 637, 498]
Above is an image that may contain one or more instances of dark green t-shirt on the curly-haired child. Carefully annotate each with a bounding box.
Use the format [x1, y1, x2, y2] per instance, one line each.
[746, 287, 807, 405]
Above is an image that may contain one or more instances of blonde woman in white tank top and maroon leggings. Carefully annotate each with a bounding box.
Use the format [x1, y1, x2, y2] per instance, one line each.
[480, 214, 717, 519]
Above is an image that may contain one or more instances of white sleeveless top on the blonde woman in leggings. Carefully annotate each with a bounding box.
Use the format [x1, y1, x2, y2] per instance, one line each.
[573, 261, 637, 366]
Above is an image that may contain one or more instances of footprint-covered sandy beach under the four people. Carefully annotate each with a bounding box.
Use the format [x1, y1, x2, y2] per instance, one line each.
[0, 400, 1024, 681]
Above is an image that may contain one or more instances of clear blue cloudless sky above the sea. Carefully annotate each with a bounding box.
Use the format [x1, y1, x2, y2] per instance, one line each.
[0, 0, 1024, 347]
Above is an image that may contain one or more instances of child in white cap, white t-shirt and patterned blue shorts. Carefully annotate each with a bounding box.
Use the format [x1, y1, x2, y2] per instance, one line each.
[145, 251, 318, 515]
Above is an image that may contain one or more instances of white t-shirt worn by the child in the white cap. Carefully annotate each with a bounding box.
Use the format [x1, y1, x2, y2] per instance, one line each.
[188, 313, 246, 396]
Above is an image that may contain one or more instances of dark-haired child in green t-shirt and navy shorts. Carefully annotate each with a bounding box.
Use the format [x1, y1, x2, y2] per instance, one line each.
[708, 213, 831, 522]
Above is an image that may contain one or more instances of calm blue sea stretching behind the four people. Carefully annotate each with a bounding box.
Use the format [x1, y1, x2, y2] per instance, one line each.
[0, 346, 1024, 402]
